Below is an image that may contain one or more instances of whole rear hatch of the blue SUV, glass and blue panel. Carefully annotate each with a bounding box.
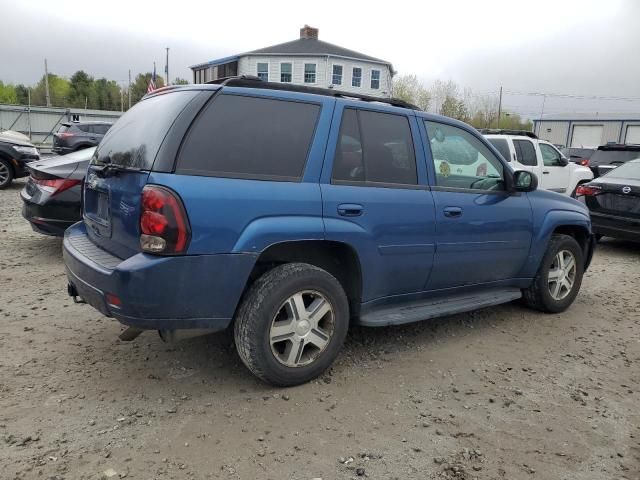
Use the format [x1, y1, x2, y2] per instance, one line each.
[83, 90, 198, 259]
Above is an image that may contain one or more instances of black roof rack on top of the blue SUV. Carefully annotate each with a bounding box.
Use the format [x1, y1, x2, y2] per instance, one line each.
[206, 75, 420, 110]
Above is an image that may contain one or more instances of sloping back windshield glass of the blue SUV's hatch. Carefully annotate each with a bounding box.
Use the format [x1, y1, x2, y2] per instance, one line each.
[92, 90, 198, 170]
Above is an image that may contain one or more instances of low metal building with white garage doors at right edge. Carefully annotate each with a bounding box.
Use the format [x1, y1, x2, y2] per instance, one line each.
[533, 113, 640, 147]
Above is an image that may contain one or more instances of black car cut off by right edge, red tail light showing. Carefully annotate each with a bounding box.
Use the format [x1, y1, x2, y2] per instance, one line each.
[576, 160, 640, 242]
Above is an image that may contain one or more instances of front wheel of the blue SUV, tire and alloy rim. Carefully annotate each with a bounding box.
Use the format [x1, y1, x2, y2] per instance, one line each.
[523, 235, 584, 313]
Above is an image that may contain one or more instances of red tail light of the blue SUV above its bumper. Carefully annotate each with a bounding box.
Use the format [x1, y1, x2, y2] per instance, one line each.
[140, 185, 191, 255]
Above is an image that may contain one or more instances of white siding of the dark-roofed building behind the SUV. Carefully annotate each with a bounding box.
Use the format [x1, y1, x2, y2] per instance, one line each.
[238, 55, 391, 97]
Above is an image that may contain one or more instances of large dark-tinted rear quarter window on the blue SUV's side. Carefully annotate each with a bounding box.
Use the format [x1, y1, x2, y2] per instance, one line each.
[177, 94, 320, 180]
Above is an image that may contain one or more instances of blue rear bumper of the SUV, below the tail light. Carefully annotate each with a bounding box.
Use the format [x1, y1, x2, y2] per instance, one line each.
[63, 223, 256, 330]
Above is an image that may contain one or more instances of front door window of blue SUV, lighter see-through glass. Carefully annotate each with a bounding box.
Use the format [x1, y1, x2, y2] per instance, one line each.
[424, 121, 504, 191]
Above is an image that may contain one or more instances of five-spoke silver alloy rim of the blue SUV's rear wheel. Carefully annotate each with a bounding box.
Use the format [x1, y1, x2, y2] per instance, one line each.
[269, 290, 335, 367]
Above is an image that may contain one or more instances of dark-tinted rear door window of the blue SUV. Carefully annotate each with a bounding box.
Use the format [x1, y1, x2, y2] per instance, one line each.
[332, 108, 418, 185]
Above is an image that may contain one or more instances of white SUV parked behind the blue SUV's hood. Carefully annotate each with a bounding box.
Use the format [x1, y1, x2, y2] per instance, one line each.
[482, 130, 593, 197]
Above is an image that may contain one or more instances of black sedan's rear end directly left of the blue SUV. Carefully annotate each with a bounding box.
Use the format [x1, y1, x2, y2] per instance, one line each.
[20, 147, 96, 236]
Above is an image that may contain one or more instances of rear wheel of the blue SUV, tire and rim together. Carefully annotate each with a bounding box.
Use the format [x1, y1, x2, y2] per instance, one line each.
[234, 263, 349, 387]
